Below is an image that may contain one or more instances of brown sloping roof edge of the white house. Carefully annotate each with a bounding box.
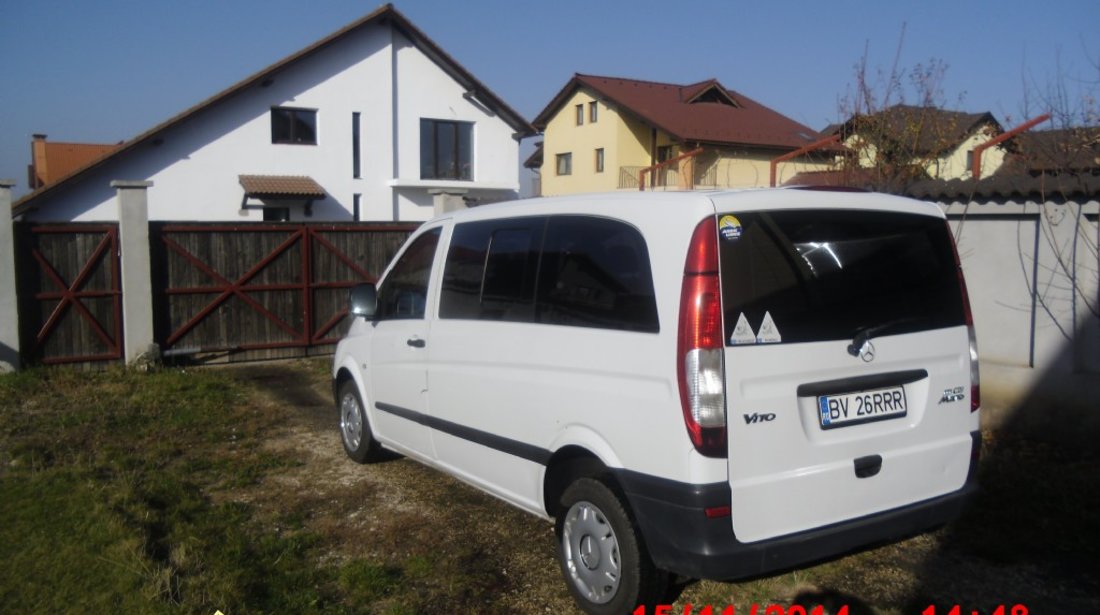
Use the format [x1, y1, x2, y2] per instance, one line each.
[12, 4, 536, 216]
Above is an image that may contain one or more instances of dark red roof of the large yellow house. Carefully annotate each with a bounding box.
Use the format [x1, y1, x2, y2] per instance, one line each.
[532, 74, 821, 150]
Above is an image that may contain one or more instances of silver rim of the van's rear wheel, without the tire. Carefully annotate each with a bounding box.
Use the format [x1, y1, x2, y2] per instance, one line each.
[561, 501, 623, 604]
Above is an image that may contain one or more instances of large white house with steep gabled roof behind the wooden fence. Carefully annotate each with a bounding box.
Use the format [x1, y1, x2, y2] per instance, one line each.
[14, 4, 535, 221]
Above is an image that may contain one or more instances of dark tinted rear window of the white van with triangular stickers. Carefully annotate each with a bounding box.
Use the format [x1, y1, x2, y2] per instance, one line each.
[718, 210, 965, 345]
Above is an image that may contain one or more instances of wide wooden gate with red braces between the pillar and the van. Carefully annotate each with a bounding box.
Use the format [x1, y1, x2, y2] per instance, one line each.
[151, 223, 416, 360]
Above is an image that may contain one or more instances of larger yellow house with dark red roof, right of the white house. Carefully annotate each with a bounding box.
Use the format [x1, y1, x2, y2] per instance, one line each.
[525, 75, 837, 196]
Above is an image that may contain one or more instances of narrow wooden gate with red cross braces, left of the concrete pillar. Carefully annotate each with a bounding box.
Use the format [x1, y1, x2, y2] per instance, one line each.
[15, 223, 122, 364]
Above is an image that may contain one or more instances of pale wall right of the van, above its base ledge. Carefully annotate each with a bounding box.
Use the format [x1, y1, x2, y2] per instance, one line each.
[947, 201, 1100, 373]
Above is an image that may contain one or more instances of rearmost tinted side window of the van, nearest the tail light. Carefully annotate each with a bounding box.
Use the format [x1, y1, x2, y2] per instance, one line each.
[536, 216, 659, 332]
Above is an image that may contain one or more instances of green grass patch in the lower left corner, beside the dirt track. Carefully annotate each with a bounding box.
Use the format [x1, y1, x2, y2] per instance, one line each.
[0, 370, 339, 613]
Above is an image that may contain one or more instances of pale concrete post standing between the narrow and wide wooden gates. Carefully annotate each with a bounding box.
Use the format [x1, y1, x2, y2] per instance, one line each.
[111, 179, 160, 365]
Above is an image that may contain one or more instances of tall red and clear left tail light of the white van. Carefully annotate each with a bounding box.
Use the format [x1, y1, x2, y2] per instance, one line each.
[677, 217, 726, 457]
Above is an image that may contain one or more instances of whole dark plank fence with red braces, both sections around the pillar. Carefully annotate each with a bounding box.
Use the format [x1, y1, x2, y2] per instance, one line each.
[15, 222, 417, 364]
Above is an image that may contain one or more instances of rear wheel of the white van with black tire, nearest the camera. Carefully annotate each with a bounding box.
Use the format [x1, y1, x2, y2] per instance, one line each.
[556, 477, 669, 615]
